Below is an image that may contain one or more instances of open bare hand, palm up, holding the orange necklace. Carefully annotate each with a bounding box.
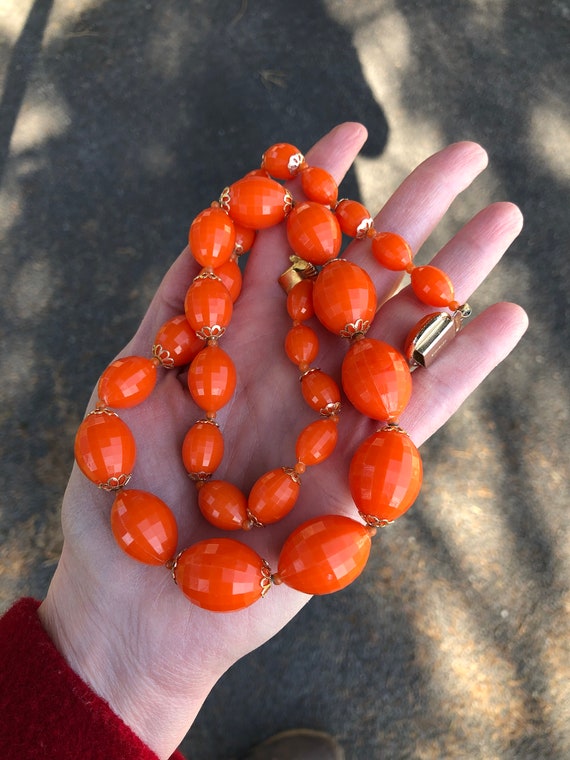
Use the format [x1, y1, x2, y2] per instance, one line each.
[40, 124, 526, 758]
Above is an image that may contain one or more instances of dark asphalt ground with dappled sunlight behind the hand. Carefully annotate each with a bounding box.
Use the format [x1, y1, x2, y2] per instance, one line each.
[0, 0, 570, 760]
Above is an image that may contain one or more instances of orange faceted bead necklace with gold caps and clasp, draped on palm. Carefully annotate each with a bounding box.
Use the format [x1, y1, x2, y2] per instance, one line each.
[75, 143, 469, 611]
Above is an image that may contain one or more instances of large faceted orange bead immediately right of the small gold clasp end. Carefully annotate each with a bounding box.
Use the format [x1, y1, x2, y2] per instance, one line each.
[313, 259, 376, 335]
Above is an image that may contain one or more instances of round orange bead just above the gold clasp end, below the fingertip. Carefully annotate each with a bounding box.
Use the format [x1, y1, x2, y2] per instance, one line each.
[287, 201, 342, 266]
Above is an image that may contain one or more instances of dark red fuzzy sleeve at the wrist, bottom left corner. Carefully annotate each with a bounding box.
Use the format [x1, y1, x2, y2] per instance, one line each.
[0, 599, 184, 760]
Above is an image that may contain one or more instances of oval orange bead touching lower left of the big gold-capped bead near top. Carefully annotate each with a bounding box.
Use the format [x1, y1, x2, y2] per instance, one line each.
[188, 208, 236, 268]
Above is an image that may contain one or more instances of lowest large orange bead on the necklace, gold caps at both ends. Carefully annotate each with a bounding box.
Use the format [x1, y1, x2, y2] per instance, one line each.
[174, 538, 267, 612]
